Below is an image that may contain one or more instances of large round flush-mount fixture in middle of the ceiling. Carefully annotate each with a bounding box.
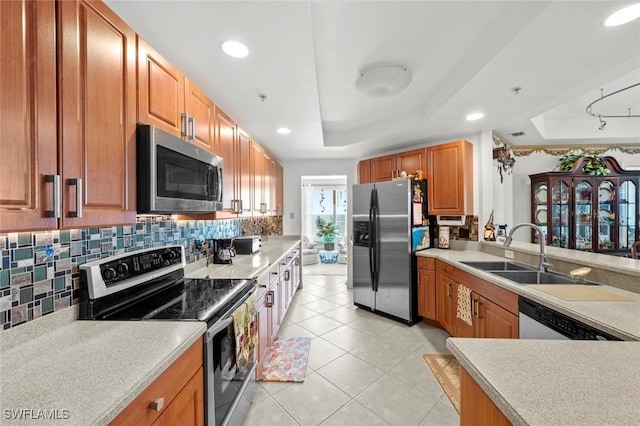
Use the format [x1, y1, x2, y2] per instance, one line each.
[356, 66, 411, 98]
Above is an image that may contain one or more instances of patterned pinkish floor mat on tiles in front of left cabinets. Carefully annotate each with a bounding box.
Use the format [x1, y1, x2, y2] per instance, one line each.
[258, 336, 311, 382]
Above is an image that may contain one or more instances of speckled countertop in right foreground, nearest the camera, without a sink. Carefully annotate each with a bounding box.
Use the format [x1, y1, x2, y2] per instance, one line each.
[447, 338, 640, 426]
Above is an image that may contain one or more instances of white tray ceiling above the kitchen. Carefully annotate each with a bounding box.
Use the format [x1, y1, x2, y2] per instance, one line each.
[106, 0, 640, 160]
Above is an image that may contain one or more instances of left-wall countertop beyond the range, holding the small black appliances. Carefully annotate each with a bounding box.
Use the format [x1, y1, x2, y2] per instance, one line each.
[185, 235, 300, 279]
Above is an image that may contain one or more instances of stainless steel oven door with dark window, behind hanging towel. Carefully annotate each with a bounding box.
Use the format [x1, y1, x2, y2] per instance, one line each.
[204, 295, 258, 426]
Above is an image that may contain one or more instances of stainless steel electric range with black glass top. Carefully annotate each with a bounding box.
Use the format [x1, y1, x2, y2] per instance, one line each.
[79, 246, 257, 426]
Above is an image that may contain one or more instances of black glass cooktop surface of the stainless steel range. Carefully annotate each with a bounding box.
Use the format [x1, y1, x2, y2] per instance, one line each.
[102, 278, 254, 323]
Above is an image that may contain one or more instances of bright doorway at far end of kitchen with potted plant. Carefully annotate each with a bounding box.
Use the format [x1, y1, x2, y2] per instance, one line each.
[301, 175, 349, 276]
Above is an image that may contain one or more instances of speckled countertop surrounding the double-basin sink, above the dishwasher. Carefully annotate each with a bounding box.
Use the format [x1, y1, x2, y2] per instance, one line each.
[416, 249, 640, 340]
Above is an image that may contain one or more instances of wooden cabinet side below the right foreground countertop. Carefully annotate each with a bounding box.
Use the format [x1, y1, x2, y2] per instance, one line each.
[460, 367, 511, 426]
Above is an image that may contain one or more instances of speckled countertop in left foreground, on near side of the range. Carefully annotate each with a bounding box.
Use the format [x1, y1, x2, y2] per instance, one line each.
[0, 308, 206, 426]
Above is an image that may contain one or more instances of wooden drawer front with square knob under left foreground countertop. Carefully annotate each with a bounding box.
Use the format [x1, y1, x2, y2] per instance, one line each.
[110, 337, 203, 426]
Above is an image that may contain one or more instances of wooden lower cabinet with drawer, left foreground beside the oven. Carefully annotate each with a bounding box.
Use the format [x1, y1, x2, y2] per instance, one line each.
[110, 337, 204, 426]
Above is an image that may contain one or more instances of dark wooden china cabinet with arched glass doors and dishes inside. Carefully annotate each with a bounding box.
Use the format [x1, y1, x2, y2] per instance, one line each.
[529, 157, 640, 255]
